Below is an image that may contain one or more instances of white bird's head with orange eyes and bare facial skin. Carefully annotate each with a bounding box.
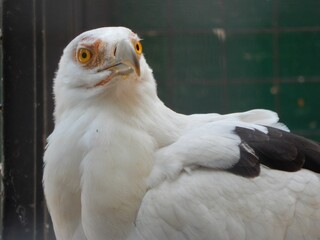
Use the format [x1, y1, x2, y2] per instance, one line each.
[54, 27, 155, 116]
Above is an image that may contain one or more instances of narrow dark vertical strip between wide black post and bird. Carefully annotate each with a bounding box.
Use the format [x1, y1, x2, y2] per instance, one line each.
[33, 0, 46, 240]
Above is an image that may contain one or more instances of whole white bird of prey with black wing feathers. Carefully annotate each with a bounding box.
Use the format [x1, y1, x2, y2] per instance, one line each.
[43, 27, 320, 240]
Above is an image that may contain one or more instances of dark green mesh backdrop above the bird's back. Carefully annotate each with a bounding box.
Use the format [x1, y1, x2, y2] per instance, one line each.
[110, 0, 320, 140]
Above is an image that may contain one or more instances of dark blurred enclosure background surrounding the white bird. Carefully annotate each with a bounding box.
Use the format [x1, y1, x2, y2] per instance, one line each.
[0, 0, 320, 240]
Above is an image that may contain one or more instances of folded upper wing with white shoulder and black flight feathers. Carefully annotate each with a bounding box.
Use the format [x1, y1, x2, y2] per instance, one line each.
[148, 120, 320, 188]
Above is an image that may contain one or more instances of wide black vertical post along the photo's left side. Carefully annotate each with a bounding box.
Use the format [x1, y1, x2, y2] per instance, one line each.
[3, 0, 38, 240]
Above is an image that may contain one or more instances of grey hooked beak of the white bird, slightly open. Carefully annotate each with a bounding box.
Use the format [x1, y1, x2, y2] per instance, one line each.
[96, 39, 140, 86]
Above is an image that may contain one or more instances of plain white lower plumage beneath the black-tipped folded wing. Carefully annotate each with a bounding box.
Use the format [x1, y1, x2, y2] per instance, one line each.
[135, 167, 320, 240]
